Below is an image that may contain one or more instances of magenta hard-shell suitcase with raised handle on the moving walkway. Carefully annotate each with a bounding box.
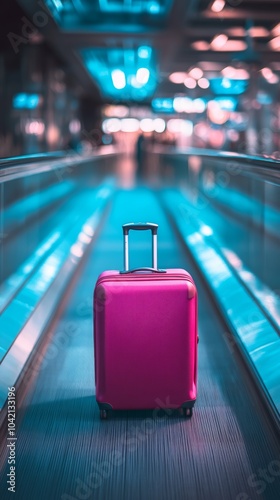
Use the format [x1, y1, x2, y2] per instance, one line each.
[94, 223, 198, 419]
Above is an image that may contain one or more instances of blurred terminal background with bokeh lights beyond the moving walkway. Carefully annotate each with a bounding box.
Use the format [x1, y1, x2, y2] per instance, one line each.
[0, 0, 280, 157]
